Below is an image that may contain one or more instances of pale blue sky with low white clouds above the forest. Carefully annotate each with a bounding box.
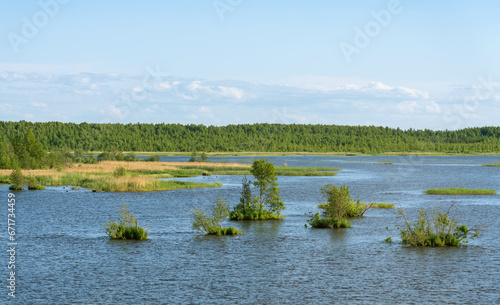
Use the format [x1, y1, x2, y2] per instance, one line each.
[0, 0, 500, 130]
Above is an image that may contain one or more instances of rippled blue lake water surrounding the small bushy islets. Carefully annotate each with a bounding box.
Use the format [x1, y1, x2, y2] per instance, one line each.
[0, 156, 500, 304]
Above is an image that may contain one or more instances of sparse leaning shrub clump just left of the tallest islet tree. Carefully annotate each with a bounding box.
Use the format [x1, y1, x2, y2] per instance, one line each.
[191, 197, 243, 236]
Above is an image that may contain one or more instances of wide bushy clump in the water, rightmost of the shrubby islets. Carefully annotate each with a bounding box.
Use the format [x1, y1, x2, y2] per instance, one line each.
[398, 204, 479, 247]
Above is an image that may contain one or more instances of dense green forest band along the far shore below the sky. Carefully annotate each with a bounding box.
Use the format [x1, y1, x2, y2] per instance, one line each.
[0, 121, 500, 156]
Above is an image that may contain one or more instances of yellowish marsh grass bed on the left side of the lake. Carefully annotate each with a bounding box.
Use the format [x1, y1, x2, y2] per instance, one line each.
[0, 161, 339, 192]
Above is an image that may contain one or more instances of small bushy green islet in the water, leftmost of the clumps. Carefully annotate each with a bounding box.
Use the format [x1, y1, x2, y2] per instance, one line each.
[104, 203, 148, 240]
